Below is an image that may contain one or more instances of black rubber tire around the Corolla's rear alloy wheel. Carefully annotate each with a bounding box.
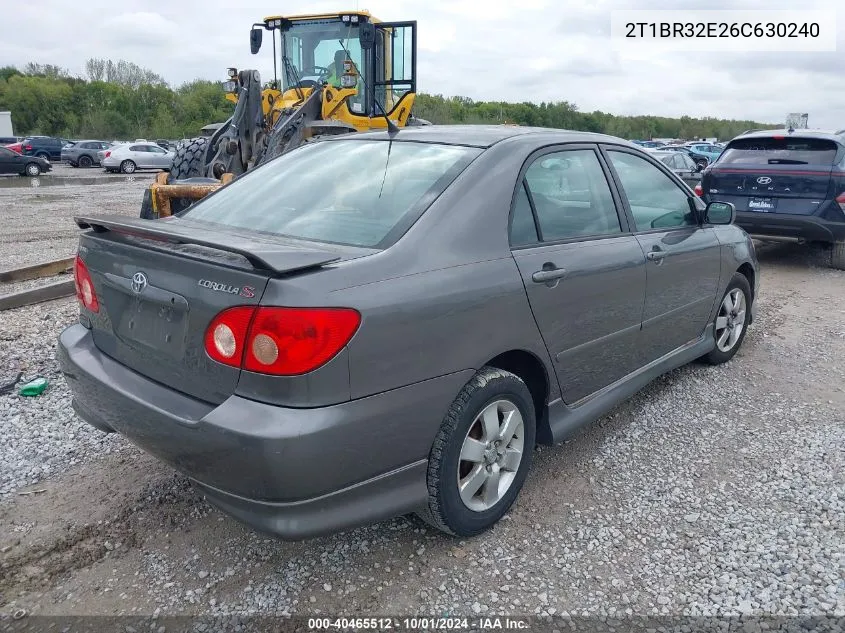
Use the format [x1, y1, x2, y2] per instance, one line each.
[418, 367, 536, 537]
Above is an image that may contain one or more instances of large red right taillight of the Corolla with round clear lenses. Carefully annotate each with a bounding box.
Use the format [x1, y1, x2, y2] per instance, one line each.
[205, 306, 361, 376]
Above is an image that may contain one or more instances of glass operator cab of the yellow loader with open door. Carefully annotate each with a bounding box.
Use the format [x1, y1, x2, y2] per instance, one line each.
[253, 11, 416, 124]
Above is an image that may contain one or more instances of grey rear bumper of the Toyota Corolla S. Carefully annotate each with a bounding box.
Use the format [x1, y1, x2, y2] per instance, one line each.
[58, 325, 472, 539]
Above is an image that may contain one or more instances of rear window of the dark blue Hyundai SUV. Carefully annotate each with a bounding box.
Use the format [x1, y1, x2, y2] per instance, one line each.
[719, 137, 838, 167]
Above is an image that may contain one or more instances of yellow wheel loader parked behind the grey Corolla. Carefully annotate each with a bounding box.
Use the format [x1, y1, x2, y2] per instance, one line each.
[141, 11, 428, 218]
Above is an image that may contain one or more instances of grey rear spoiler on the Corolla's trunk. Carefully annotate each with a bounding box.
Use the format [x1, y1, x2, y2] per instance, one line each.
[73, 215, 340, 274]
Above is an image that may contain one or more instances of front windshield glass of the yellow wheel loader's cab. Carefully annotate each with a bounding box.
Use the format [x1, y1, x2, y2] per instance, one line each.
[282, 19, 369, 113]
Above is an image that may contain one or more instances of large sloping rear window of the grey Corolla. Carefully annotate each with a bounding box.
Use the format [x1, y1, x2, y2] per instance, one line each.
[181, 140, 481, 248]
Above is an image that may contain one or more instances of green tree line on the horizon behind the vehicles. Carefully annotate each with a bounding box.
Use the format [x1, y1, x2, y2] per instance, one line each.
[0, 58, 781, 139]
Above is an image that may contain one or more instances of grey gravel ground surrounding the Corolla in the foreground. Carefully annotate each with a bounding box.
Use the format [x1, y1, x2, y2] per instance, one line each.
[0, 177, 845, 616]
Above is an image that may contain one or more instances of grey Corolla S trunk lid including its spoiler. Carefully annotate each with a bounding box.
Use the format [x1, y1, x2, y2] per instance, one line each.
[76, 217, 340, 404]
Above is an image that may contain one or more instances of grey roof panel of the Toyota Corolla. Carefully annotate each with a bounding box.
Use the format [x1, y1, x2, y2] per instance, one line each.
[340, 125, 638, 148]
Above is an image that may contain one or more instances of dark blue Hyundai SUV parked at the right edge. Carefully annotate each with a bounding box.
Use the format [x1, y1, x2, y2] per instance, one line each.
[701, 130, 845, 270]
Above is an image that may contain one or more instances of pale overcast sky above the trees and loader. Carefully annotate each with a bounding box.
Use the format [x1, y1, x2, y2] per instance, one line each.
[0, 0, 845, 129]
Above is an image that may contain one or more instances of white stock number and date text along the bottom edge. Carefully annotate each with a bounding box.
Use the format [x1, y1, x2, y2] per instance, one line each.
[308, 617, 530, 631]
